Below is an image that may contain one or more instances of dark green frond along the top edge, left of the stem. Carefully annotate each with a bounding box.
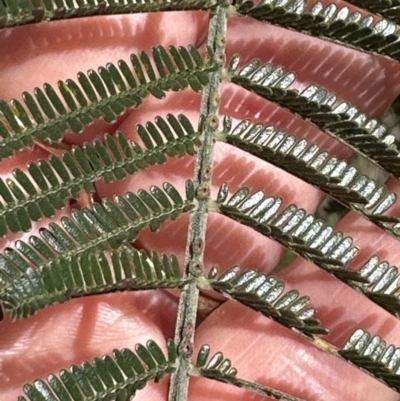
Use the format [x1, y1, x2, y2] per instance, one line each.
[0, 0, 215, 29]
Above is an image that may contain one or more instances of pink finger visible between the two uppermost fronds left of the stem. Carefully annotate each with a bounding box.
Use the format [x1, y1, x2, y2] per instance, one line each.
[0, 12, 207, 99]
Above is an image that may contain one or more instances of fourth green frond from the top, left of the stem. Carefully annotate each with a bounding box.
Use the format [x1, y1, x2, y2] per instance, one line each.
[0, 181, 194, 318]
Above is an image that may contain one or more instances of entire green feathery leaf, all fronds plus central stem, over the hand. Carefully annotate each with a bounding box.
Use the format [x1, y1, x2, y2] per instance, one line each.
[0, 0, 400, 401]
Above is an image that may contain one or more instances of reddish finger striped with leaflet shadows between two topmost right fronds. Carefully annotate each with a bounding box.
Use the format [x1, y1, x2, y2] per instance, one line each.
[227, 5, 400, 118]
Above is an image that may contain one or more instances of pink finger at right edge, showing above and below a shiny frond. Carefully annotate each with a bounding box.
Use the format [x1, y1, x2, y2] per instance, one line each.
[278, 173, 400, 346]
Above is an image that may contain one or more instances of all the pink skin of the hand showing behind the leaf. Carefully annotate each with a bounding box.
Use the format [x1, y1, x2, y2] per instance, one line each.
[0, 1, 400, 401]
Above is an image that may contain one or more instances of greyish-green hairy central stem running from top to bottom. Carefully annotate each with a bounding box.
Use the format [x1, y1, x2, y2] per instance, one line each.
[169, 0, 230, 401]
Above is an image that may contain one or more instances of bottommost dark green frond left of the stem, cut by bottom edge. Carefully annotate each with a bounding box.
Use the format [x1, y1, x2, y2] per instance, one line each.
[18, 340, 176, 401]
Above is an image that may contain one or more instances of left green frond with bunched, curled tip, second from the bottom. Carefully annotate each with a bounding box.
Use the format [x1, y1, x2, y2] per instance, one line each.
[0, 249, 187, 318]
